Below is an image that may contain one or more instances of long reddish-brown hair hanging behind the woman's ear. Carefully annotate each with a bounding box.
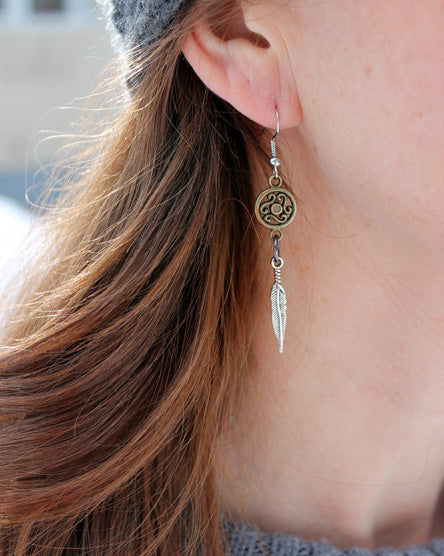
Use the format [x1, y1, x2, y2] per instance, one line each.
[0, 1, 268, 556]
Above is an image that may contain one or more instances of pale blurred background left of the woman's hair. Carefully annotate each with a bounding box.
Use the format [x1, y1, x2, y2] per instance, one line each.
[0, 0, 113, 283]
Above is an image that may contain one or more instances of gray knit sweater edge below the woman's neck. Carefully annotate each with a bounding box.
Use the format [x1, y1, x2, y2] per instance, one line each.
[223, 520, 444, 556]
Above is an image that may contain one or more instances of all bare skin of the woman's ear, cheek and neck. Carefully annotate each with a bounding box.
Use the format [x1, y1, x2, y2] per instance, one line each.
[183, 0, 444, 550]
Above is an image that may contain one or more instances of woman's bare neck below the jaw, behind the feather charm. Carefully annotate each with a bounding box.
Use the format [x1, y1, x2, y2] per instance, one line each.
[217, 128, 444, 550]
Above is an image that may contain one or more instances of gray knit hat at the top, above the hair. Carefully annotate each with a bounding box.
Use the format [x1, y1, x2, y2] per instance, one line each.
[97, 0, 186, 54]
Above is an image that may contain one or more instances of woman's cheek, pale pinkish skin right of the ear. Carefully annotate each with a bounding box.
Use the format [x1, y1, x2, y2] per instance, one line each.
[286, 0, 444, 238]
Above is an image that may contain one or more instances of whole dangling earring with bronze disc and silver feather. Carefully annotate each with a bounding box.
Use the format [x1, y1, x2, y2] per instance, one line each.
[255, 108, 297, 353]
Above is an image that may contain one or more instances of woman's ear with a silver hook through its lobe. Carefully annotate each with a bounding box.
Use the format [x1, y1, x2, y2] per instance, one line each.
[182, 2, 301, 129]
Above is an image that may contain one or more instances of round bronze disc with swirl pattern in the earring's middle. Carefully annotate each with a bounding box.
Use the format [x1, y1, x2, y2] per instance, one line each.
[254, 174, 297, 230]
